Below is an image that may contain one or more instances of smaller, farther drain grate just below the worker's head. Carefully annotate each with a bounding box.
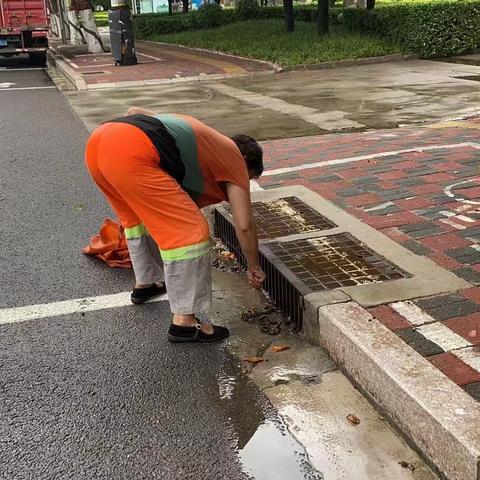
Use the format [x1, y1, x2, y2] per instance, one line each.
[252, 197, 336, 240]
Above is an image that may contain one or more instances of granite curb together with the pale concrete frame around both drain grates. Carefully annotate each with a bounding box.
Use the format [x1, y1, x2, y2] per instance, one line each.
[232, 186, 480, 480]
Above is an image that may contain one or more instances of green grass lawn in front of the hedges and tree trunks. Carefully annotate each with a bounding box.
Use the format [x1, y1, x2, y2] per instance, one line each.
[155, 19, 400, 66]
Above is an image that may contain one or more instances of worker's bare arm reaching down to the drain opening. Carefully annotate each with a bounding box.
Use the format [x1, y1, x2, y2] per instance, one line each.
[226, 182, 266, 288]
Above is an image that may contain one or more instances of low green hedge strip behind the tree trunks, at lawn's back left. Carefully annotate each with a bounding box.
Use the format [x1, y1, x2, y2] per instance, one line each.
[134, 4, 340, 39]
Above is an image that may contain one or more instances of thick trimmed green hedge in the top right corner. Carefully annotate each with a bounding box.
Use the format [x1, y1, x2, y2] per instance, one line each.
[342, 0, 480, 58]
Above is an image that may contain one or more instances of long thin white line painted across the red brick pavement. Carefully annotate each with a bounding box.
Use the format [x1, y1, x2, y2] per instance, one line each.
[263, 142, 480, 179]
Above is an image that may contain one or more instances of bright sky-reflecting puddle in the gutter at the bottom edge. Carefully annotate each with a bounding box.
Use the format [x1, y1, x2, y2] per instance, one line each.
[239, 420, 323, 480]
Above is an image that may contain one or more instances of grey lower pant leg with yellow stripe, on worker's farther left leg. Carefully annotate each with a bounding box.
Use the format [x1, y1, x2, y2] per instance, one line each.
[125, 223, 165, 285]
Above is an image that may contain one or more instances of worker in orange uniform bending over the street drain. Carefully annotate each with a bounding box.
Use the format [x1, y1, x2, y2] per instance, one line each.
[86, 108, 265, 342]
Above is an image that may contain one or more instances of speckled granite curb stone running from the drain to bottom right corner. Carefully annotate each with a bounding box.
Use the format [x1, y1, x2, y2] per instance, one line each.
[305, 298, 480, 480]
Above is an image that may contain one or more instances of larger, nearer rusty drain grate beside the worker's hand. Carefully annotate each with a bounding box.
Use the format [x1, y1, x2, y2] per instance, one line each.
[267, 233, 409, 291]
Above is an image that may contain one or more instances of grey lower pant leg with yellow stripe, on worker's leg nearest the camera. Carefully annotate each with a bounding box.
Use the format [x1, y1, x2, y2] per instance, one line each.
[160, 241, 212, 315]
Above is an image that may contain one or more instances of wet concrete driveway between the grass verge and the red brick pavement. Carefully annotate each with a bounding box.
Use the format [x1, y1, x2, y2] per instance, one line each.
[61, 56, 480, 140]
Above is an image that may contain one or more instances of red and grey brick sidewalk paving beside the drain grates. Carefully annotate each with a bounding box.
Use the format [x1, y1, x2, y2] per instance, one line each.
[259, 119, 480, 400]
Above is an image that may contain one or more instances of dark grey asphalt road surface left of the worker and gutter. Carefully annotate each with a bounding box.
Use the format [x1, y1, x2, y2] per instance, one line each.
[0, 60, 273, 480]
